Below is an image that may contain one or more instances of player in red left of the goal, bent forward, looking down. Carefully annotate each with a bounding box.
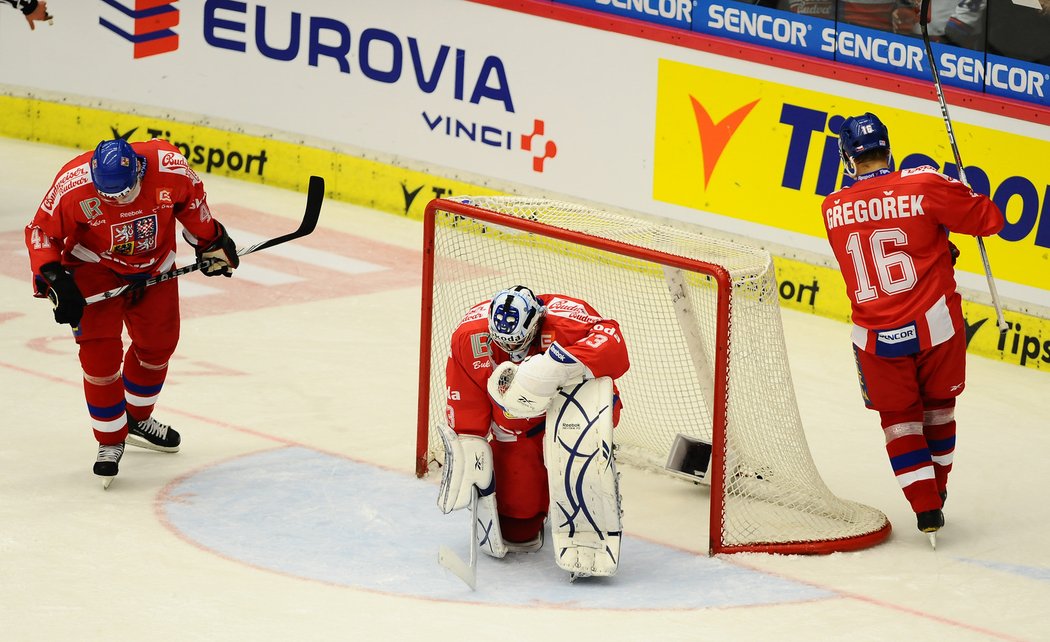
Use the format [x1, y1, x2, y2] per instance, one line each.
[25, 139, 238, 488]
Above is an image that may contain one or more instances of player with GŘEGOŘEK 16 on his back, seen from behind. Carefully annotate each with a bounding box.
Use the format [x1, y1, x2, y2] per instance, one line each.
[821, 112, 1005, 544]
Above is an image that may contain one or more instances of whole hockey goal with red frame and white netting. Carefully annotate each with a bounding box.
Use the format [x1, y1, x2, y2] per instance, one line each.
[416, 196, 890, 554]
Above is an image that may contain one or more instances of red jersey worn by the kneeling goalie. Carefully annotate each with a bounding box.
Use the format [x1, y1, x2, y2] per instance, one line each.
[445, 294, 630, 439]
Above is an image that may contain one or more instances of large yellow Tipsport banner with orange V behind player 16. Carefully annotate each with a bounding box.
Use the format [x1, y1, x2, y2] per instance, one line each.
[653, 60, 1050, 290]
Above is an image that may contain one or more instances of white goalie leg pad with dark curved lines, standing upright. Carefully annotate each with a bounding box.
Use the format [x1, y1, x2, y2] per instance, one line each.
[544, 377, 623, 578]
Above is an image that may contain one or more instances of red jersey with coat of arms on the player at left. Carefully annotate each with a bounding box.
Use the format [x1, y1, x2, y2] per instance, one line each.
[25, 139, 219, 295]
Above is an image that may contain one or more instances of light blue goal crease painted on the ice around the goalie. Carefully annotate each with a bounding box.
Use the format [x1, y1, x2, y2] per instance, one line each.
[158, 447, 840, 610]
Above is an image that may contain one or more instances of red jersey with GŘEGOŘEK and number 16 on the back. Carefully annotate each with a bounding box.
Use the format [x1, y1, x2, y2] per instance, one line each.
[821, 166, 1005, 356]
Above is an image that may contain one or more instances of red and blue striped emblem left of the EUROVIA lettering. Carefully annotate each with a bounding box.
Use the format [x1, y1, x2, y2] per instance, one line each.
[99, 0, 179, 59]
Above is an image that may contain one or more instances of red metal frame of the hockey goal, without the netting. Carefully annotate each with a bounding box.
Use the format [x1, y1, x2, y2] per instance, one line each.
[415, 199, 890, 555]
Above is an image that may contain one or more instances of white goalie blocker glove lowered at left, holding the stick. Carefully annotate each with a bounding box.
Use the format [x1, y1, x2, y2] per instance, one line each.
[438, 426, 495, 515]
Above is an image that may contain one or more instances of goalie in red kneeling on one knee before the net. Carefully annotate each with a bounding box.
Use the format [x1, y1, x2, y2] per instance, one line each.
[438, 286, 629, 580]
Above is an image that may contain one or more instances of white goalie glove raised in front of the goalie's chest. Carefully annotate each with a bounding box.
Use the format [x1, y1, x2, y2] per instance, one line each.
[488, 341, 587, 419]
